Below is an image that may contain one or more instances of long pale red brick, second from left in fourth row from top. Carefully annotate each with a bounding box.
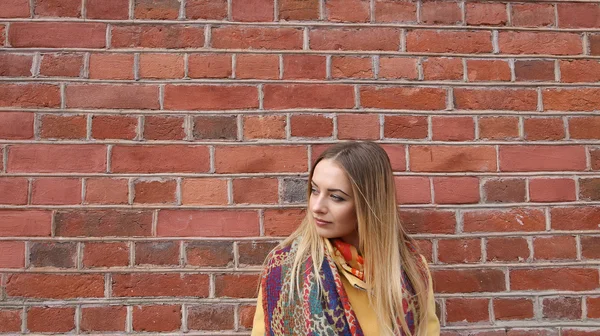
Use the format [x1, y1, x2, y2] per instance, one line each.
[65, 84, 160, 109]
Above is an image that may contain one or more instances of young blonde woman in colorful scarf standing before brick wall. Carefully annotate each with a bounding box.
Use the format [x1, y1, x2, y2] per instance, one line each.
[252, 142, 440, 336]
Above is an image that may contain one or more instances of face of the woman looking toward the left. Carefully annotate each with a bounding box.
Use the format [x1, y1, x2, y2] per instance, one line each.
[308, 159, 359, 248]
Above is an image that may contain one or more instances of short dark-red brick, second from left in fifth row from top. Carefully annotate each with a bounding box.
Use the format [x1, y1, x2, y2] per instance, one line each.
[39, 114, 87, 139]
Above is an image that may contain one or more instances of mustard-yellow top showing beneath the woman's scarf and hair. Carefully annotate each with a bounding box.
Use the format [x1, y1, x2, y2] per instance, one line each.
[252, 258, 440, 336]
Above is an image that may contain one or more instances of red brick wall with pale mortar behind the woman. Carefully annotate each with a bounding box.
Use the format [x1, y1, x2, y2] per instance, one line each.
[0, 0, 600, 336]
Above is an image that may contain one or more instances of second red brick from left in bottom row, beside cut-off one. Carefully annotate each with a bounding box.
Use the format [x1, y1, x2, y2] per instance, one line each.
[27, 307, 75, 333]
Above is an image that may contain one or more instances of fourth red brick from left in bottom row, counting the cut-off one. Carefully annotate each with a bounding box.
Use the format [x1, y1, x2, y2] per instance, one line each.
[133, 305, 181, 332]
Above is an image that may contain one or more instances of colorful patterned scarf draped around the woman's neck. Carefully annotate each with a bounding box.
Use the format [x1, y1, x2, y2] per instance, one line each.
[261, 239, 417, 336]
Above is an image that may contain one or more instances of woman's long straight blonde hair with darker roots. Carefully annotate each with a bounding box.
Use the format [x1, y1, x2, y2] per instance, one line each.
[280, 142, 428, 335]
